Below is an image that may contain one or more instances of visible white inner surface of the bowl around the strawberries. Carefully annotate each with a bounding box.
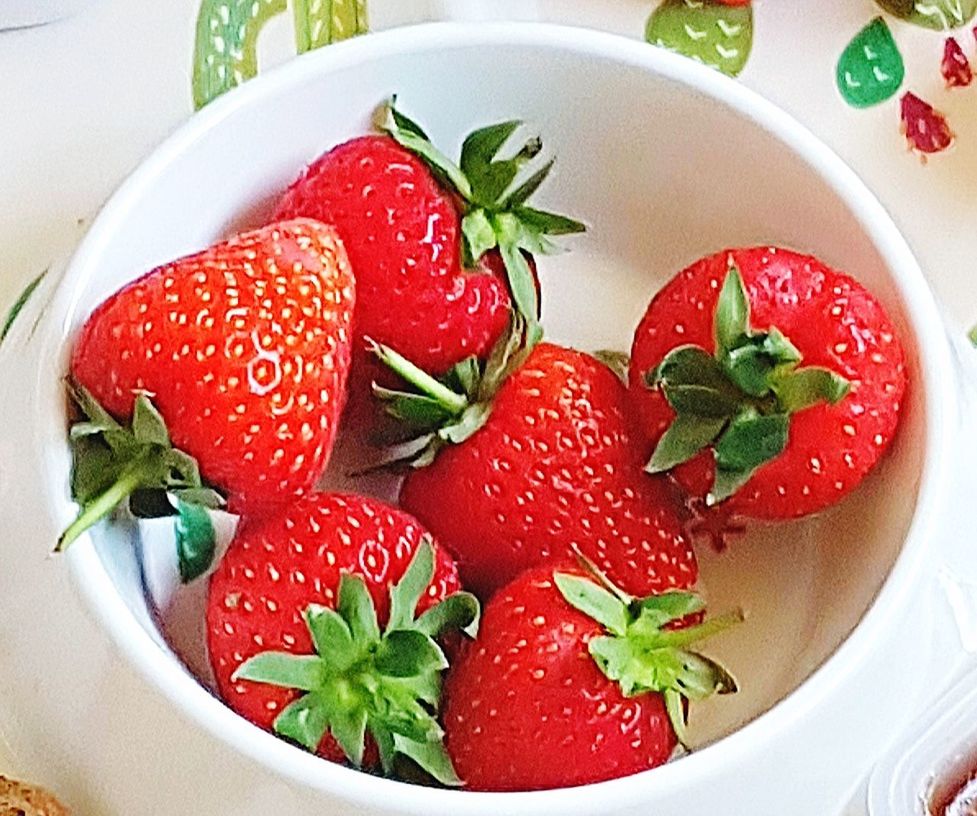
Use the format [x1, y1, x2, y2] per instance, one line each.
[59, 28, 925, 784]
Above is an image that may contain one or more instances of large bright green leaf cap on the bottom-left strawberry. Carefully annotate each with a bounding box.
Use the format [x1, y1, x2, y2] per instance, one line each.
[233, 538, 479, 786]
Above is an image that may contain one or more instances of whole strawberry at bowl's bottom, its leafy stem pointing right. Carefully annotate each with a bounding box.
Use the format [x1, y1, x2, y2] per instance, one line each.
[444, 566, 742, 791]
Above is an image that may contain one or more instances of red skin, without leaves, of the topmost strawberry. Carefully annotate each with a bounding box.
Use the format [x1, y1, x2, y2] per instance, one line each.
[275, 136, 510, 381]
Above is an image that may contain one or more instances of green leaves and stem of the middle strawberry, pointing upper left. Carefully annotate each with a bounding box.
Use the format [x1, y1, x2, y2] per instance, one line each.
[366, 314, 533, 468]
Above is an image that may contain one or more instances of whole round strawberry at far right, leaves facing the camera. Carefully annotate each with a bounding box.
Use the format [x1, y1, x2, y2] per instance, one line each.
[630, 247, 906, 519]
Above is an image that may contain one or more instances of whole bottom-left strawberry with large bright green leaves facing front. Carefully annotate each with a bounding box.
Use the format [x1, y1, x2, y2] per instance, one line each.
[207, 493, 478, 783]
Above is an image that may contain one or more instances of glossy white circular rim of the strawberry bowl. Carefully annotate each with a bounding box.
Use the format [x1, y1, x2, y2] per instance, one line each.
[53, 22, 955, 816]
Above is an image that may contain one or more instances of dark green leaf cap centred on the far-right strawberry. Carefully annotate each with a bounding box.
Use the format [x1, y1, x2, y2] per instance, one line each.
[645, 256, 851, 505]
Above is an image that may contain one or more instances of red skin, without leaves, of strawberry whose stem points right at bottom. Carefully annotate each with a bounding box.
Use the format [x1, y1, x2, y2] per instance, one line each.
[444, 566, 676, 791]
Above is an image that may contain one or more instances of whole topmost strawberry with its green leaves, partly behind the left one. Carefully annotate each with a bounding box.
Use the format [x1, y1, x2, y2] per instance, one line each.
[275, 104, 583, 404]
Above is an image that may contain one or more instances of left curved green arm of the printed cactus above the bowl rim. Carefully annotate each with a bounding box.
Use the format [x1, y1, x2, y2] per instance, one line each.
[193, 0, 287, 110]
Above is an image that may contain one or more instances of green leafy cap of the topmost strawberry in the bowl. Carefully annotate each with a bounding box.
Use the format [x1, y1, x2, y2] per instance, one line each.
[379, 97, 586, 339]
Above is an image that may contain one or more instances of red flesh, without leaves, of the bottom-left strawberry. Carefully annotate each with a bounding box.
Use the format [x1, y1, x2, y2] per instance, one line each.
[206, 493, 460, 763]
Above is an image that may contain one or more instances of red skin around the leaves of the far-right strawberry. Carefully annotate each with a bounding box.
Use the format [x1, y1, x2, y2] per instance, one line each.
[630, 247, 907, 519]
